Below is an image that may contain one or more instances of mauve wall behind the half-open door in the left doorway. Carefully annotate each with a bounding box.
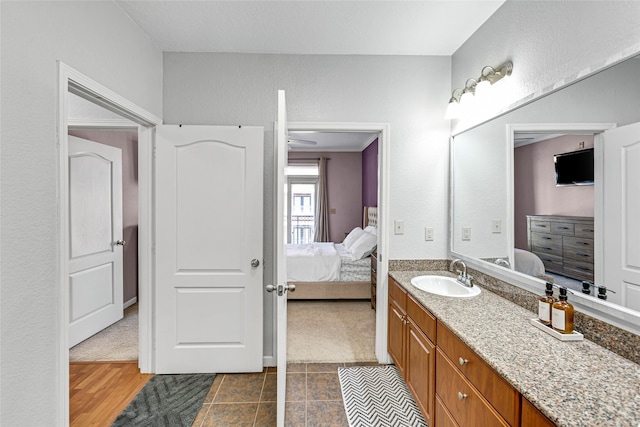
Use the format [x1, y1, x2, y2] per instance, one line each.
[69, 130, 138, 302]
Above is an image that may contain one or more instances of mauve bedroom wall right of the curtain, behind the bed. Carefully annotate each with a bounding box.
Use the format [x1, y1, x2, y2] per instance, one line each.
[289, 151, 362, 243]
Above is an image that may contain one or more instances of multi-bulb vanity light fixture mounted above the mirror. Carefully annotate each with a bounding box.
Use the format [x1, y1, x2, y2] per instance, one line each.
[445, 61, 513, 119]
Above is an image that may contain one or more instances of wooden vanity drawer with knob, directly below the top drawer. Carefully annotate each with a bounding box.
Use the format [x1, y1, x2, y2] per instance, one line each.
[436, 349, 515, 427]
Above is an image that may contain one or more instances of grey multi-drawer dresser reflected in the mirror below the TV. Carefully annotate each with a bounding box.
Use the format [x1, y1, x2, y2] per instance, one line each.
[527, 215, 594, 281]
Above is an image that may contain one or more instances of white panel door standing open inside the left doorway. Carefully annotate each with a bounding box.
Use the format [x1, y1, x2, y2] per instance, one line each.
[69, 136, 124, 347]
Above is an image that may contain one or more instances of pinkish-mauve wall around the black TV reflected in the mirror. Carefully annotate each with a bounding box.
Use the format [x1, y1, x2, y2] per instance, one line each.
[513, 135, 594, 249]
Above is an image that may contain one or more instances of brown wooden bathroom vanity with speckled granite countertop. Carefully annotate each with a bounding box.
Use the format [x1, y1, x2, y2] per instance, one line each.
[388, 271, 640, 427]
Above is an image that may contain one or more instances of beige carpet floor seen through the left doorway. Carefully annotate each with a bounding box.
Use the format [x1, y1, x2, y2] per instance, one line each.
[69, 304, 138, 362]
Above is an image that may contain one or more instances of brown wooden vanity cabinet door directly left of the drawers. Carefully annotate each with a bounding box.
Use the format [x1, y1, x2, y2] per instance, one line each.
[405, 318, 436, 425]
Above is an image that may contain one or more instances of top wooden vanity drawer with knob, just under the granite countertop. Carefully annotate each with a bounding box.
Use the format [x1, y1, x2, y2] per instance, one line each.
[436, 322, 520, 425]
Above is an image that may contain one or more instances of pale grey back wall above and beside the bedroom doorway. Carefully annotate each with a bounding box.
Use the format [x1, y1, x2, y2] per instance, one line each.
[163, 53, 450, 362]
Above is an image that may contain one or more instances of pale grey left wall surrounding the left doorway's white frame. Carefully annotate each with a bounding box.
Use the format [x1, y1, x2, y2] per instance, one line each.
[0, 1, 162, 426]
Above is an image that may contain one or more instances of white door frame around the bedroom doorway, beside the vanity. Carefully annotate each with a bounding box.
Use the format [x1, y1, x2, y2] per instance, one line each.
[282, 122, 391, 364]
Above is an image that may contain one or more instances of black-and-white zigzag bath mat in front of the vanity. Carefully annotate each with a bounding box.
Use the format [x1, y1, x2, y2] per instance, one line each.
[338, 365, 427, 427]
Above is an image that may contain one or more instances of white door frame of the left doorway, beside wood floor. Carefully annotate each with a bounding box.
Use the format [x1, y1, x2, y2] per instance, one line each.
[56, 61, 162, 426]
